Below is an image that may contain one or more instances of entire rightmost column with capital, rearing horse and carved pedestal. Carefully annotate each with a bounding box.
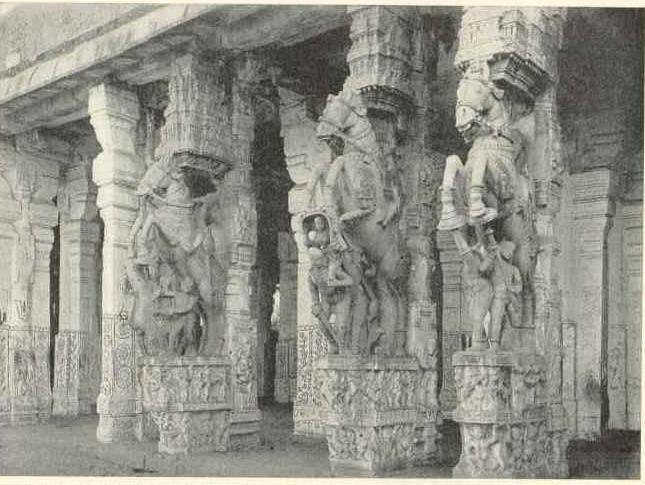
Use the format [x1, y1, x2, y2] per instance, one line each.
[439, 7, 568, 477]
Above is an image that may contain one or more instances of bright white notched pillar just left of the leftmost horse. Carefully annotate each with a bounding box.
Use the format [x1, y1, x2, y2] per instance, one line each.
[88, 84, 144, 443]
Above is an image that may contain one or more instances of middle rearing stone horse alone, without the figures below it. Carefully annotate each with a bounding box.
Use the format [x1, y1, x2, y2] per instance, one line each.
[309, 85, 407, 355]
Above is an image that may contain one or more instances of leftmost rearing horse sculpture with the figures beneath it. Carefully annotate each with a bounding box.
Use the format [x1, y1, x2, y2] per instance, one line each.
[127, 156, 224, 355]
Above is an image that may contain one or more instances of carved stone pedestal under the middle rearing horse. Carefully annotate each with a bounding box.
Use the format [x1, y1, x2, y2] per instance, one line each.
[318, 355, 418, 476]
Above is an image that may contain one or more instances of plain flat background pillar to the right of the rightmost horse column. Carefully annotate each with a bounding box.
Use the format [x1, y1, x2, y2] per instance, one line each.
[571, 168, 615, 440]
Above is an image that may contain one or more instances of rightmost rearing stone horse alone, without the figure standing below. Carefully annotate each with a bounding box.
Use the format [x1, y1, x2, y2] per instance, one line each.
[437, 76, 534, 338]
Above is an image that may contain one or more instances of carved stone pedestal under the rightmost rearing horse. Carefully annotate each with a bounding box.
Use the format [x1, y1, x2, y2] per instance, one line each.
[453, 350, 550, 478]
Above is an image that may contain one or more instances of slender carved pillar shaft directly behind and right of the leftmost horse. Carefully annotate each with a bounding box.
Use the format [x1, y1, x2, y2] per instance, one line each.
[221, 57, 262, 447]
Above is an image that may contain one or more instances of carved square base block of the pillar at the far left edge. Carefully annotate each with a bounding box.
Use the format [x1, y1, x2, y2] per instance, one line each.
[0, 325, 52, 426]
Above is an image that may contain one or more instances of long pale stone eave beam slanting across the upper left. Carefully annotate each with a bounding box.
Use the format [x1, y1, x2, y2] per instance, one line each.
[0, 5, 348, 135]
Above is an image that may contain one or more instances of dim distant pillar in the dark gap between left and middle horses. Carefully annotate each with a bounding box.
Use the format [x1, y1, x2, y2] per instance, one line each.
[272, 232, 298, 403]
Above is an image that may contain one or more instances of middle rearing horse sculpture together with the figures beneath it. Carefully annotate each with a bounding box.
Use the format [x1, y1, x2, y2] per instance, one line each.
[303, 84, 407, 355]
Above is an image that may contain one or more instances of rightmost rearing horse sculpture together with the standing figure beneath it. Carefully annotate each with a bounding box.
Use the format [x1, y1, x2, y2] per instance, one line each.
[437, 76, 535, 348]
